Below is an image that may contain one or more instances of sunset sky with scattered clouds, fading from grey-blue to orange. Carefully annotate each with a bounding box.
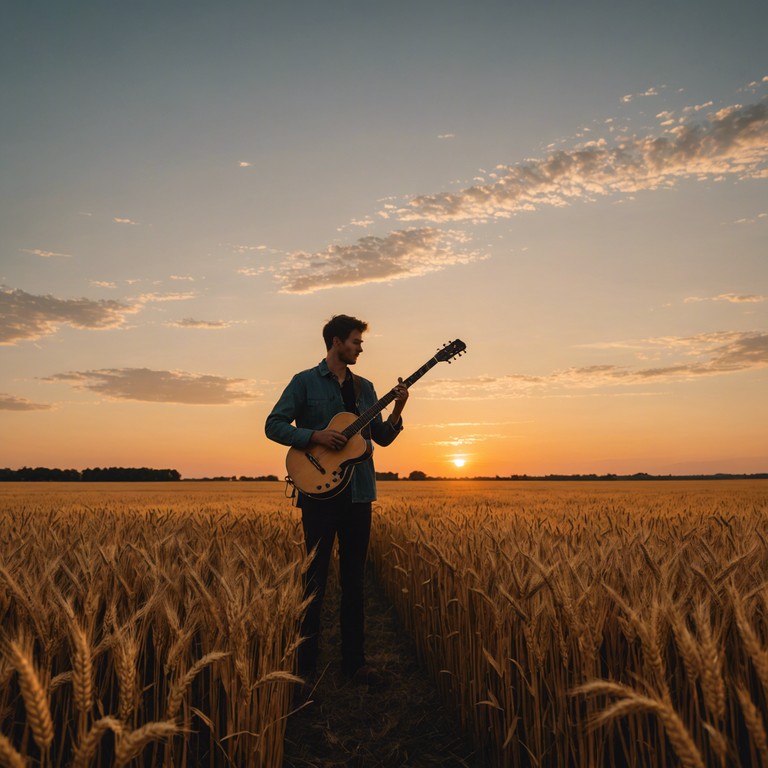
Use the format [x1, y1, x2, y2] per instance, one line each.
[0, 0, 768, 477]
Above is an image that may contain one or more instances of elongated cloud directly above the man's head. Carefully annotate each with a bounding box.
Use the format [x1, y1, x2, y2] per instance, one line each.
[276, 227, 480, 293]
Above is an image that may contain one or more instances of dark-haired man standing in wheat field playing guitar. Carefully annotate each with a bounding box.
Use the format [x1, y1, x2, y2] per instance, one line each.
[265, 315, 408, 684]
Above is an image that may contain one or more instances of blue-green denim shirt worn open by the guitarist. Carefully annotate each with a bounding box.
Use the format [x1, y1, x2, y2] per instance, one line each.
[264, 360, 403, 502]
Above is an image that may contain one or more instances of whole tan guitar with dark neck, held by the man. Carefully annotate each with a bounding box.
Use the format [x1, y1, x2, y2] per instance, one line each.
[285, 339, 467, 499]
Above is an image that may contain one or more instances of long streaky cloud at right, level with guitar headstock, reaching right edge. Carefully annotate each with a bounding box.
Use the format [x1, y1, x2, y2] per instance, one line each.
[423, 331, 768, 400]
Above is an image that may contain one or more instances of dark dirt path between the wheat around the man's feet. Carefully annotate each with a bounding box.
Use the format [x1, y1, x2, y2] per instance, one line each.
[283, 567, 478, 768]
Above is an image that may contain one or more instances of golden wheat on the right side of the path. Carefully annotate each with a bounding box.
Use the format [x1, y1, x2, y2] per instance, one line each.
[373, 481, 768, 768]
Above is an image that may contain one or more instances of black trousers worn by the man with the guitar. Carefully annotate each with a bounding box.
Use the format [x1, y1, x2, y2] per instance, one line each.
[299, 487, 371, 675]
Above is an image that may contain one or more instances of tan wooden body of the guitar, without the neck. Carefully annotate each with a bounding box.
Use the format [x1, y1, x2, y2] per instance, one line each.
[285, 412, 373, 499]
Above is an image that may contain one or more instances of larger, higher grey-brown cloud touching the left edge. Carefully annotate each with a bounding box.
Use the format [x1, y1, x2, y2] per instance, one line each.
[0, 287, 141, 345]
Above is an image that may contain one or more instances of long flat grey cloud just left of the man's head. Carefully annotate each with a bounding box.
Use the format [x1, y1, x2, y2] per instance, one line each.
[43, 368, 258, 405]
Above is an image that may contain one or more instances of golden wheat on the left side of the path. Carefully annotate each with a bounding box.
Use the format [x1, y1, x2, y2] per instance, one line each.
[0, 484, 312, 766]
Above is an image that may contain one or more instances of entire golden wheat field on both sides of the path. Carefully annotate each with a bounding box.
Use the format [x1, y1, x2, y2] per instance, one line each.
[0, 481, 768, 768]
